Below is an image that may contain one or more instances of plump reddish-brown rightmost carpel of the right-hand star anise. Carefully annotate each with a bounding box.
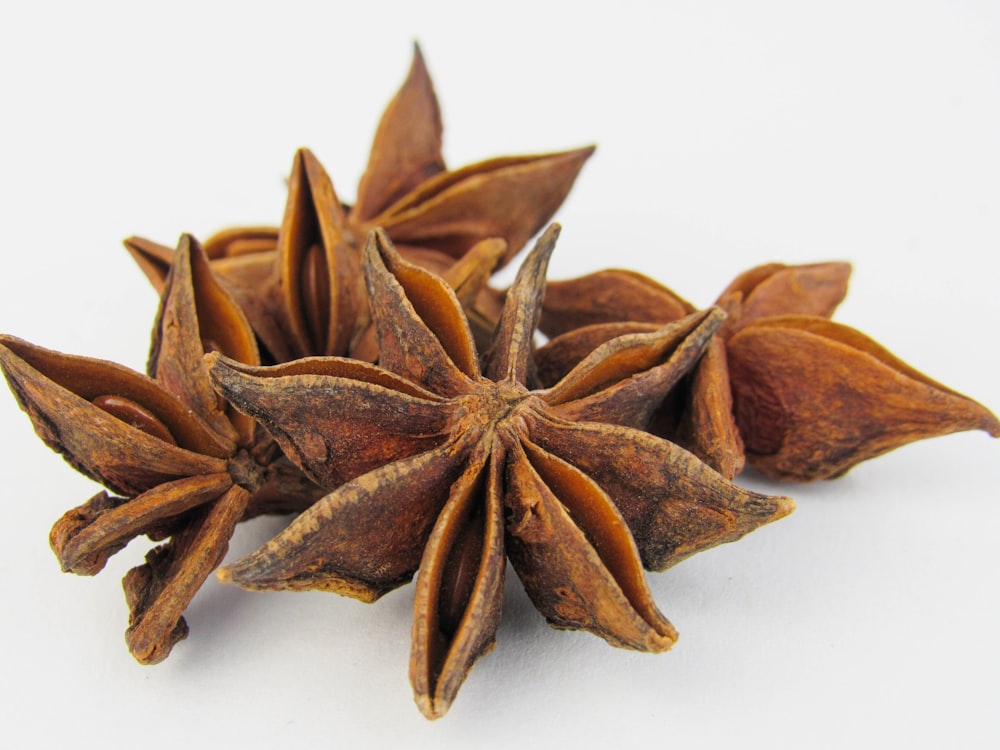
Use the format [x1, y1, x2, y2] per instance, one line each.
[729, 316, 1000, 481]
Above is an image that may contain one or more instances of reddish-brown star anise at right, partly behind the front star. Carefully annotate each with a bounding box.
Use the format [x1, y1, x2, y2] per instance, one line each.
[538, 263, 1000, 481]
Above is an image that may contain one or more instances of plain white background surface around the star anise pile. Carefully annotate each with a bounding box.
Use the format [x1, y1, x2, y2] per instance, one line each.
[0, 0, 1000, 748]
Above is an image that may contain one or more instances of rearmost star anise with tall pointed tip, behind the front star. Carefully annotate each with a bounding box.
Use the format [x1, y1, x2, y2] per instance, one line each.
[126, 47, 594, 362]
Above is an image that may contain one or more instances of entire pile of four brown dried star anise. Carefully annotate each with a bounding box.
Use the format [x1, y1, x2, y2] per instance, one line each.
[0, 50, 1000, 718]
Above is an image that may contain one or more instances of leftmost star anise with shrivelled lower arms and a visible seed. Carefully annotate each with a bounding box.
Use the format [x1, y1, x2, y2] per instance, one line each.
[0, 237, 322, 663]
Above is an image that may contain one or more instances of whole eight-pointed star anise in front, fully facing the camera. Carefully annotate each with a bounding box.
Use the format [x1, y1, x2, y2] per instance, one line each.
[209, 226, 793, 718]
